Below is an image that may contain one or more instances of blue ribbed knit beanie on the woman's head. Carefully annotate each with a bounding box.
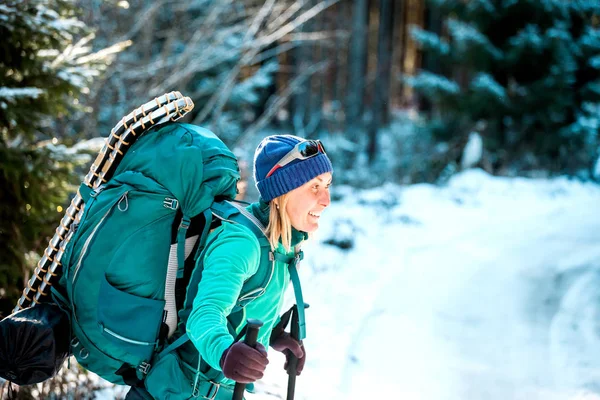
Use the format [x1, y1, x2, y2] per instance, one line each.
[254, 135, 333, 202]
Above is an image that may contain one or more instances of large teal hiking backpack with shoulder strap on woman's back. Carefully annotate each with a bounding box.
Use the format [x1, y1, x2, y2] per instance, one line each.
[52, 123, 293, 395]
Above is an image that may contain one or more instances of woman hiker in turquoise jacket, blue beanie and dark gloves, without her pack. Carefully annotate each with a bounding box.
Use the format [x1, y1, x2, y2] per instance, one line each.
[177, 135, 333, 399]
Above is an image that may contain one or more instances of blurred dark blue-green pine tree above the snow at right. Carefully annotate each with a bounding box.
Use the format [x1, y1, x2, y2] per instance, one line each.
[407, 0, 600, 172]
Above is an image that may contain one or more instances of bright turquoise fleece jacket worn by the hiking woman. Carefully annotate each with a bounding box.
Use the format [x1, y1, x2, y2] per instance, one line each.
[186, 202, 308, 384]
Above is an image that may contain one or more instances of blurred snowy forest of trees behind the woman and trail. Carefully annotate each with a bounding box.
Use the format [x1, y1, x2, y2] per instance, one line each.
[0, 0, 600, 396]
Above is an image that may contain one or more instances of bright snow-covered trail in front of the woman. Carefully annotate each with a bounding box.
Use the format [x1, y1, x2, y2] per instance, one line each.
[252, 171, 600, 400]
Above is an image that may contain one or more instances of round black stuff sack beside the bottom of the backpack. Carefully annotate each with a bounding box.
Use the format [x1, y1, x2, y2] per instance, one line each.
[0, 303, 70, 385]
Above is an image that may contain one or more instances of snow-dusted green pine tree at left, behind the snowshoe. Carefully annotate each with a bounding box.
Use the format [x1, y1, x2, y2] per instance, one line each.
[0, 0, 111, 314]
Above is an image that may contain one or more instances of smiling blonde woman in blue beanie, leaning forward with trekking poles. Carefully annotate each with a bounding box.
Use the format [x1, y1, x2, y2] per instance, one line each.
[127, 135, 333, 400]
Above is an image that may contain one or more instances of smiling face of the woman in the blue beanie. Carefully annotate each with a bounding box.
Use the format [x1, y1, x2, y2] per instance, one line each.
[286, 172, 332, 233]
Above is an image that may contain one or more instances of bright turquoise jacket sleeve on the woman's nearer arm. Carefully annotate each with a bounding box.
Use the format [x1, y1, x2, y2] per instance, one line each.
[186, 223, 260, 371]
